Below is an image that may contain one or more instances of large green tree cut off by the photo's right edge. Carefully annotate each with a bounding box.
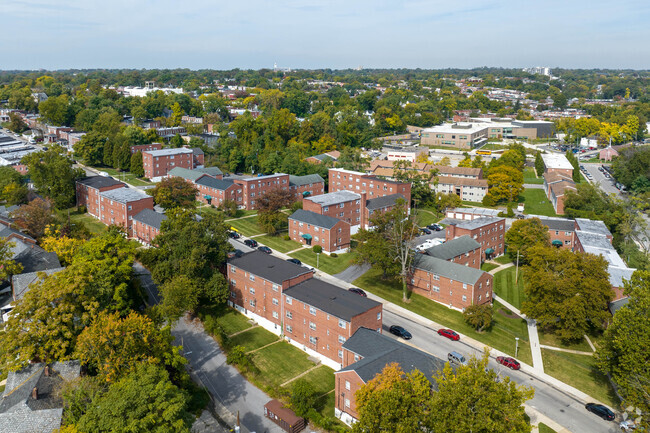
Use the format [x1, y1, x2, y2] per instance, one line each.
[596, 271, 650, 429]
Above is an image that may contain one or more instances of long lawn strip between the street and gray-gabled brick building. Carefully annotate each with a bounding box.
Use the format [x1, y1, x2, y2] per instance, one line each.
[354, 268, 532, 364]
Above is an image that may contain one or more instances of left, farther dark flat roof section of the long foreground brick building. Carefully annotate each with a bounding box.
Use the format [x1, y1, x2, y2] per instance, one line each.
[228, 250, 313, 284]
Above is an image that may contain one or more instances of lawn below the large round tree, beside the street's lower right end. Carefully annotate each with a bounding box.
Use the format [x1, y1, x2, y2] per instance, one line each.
[542, 349, 620, 408]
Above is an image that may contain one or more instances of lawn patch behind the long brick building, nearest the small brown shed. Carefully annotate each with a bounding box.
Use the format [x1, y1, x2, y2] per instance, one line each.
[253, 341, 314, 388]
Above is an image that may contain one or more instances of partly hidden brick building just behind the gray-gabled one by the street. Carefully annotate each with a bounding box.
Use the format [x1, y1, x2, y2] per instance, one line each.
[445, 217, 506, 259]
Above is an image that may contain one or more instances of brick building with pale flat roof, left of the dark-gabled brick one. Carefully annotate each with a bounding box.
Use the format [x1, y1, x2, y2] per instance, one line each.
[98, 188, 153, 235]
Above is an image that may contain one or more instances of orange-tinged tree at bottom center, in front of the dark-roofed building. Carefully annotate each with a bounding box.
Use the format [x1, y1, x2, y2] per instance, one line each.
[352, 363, 432, 433]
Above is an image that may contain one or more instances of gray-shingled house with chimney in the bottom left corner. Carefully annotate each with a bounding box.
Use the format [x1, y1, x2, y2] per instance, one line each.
[0, 361, 81, 433]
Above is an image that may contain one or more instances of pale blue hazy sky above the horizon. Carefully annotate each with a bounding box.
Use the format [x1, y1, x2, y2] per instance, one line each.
[0, 0, 650, 70]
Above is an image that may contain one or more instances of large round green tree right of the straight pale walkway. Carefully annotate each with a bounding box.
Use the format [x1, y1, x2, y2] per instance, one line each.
[521, 245, 614, 341]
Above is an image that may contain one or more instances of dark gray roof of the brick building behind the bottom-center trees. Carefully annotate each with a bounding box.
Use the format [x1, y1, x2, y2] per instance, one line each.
[335, 328, 445, 388]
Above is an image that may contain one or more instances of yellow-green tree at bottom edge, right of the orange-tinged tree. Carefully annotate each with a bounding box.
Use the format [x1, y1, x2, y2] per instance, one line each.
[430, 352, 534, 433]
